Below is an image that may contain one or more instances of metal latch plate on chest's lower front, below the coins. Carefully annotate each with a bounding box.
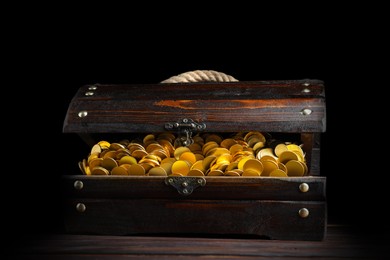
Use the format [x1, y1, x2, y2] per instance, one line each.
[165, 176, 206, 195]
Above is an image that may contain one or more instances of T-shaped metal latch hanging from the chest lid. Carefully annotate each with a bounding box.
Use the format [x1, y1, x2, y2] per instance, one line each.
[165, 118, 206, 146]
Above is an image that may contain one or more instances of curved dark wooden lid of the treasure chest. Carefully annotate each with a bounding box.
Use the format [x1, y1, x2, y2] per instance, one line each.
[63, 80, 326, 134]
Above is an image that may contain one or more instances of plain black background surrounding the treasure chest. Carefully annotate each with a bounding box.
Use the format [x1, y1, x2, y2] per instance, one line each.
[2, 7, 389, 241]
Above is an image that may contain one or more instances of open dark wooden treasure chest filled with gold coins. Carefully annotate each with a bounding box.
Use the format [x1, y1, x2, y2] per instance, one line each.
[62, 80, 327, 240]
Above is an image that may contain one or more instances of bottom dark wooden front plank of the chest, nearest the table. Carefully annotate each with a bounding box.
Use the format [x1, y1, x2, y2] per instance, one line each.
[64, 199, 326, 240]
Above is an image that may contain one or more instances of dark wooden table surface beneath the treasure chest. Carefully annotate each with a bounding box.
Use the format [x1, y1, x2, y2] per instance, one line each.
[6, 225, 390, 259]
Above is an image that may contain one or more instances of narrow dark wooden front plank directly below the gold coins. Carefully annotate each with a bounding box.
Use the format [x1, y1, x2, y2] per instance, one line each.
[62, 175, 326, 201]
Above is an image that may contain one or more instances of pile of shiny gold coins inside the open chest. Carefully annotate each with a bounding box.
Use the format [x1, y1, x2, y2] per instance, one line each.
[79, 131, 308, 177]
